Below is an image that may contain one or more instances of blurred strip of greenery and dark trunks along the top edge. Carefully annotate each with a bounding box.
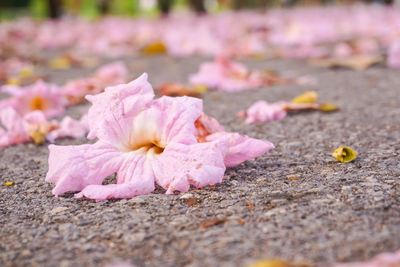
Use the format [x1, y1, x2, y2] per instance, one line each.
[0, 0, 394, 20]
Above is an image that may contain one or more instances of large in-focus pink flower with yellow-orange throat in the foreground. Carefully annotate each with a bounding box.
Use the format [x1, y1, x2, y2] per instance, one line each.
[46, 74, 274, 200]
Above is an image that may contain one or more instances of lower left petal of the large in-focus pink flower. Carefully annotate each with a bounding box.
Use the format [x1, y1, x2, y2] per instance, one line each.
[46, 141, 121, 196]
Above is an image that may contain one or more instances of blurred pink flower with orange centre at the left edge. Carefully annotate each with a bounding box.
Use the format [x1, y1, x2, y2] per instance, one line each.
[0, 81, 66, 118]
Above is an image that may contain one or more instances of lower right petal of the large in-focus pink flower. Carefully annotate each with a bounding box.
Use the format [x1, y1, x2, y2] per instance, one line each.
[153, 140, 228, 194]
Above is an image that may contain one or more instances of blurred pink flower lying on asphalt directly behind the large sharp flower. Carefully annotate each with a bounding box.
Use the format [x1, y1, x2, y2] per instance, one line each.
[189, 57, 263, 91]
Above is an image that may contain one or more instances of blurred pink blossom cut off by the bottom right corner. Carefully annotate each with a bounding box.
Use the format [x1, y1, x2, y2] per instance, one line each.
[333, 250, 400, 267]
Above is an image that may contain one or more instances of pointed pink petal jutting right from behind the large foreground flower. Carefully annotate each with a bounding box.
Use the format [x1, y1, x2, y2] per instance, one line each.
[206, 132, 274, 167]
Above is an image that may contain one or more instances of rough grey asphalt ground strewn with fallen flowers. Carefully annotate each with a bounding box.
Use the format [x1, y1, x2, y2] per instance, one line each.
[0, 56, 400, 266]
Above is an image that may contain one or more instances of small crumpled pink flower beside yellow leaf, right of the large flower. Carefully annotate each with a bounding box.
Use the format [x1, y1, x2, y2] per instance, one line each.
[238, 101, 287, 124]
